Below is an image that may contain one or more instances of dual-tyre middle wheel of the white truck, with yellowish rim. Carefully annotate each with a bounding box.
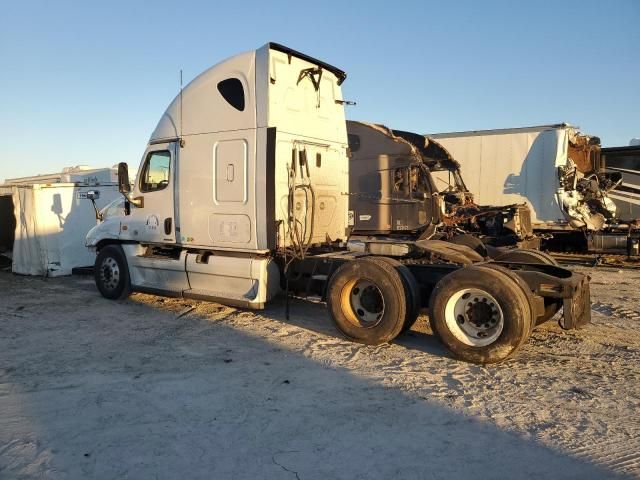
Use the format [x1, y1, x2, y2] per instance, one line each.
[327, 259, 407, 345]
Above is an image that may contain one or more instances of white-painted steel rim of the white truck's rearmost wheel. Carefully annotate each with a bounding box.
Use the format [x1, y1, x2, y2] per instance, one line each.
[444, 288, 504, 347]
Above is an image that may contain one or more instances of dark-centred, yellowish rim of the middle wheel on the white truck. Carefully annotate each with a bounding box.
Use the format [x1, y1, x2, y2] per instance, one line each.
[340, 279, 385, 328]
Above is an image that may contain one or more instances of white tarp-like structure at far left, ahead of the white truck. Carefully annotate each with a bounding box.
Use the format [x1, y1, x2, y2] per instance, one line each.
[0, 169, 120, 276]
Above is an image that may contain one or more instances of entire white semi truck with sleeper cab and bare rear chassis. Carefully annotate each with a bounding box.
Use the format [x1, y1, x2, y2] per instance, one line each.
[86, 43, 590, 363]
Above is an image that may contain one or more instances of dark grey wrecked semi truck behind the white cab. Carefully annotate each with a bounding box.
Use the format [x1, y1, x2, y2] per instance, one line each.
[347, 121, 539, 251]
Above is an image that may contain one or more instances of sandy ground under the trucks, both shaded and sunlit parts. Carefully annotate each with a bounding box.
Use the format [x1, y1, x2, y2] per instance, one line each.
[0, 269, 640, 480]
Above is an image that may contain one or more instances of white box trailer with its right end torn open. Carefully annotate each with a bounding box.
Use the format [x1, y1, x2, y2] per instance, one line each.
[426, 123, 630, 255]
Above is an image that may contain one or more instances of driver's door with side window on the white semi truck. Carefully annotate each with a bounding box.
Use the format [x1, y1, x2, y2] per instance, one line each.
[131, 142, 177, 243]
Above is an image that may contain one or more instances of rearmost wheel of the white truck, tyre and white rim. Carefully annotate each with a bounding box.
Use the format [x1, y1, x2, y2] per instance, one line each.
[429, 266, 532, 364]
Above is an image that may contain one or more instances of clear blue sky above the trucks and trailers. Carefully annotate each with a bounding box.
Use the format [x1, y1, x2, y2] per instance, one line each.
[0, 0, 640, 180]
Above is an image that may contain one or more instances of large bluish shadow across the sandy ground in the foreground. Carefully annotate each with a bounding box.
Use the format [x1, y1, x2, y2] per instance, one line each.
[0, 273, 632, 479]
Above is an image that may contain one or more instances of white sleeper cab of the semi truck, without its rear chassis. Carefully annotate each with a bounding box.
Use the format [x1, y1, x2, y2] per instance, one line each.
[87, 43, 348, 308]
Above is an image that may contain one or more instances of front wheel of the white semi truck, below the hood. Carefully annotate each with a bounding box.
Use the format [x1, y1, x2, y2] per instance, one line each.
[93, 245, 131, 300]
